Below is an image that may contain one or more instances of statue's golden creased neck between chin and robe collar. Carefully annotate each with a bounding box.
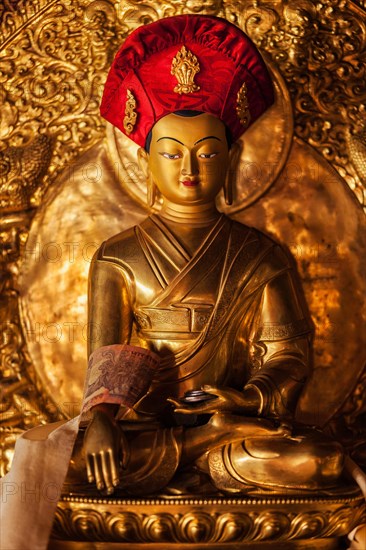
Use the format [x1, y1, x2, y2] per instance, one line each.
[160, 200, 220, 227]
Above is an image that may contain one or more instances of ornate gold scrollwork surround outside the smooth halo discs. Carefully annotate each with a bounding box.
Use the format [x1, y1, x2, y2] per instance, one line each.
[0, 0, 366, 548]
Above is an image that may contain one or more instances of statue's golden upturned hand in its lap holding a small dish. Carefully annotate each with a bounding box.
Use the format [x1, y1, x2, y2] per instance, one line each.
[168, 386, 253, 414]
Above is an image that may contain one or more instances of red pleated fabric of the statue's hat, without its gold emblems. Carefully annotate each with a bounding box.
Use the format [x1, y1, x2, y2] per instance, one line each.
[101, 15, 273, 147]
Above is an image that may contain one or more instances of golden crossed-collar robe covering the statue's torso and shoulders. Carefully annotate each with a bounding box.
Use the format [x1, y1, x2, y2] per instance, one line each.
[89, 216, 311, 417]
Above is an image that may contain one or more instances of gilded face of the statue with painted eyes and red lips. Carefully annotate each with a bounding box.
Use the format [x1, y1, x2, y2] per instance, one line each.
[139, 113, 229, 204]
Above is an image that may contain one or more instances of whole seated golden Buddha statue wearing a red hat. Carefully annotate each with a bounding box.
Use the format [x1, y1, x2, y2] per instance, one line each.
[67, 16, 343, 495]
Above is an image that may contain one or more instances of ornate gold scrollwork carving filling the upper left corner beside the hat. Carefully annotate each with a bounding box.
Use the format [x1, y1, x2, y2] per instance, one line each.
[0, 0, 121, 206]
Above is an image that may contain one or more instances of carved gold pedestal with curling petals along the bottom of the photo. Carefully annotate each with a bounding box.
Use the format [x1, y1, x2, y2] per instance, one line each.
[49, 487, 365, 550]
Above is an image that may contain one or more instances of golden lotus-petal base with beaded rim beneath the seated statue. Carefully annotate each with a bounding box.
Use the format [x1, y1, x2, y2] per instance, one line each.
[53, 493, 364, 548]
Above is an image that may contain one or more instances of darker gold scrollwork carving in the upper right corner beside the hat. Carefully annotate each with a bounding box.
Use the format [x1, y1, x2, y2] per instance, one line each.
[229, 0, 366, 207]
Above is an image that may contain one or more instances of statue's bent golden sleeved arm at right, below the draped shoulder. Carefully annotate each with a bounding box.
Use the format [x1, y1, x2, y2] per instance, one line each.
[244, 269, 312, 418]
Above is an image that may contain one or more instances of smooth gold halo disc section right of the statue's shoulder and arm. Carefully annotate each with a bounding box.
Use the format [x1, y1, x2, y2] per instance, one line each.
[235, 139, 366, 425]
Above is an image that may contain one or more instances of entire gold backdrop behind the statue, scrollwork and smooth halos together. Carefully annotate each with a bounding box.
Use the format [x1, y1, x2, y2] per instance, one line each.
[0, 0, 366, 488]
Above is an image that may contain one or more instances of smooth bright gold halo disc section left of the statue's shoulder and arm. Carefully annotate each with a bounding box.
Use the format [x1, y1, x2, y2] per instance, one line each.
[20, 146, 145, 417]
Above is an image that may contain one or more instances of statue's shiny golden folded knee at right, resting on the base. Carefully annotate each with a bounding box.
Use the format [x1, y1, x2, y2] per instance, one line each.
[208, 428, 344, 492]
